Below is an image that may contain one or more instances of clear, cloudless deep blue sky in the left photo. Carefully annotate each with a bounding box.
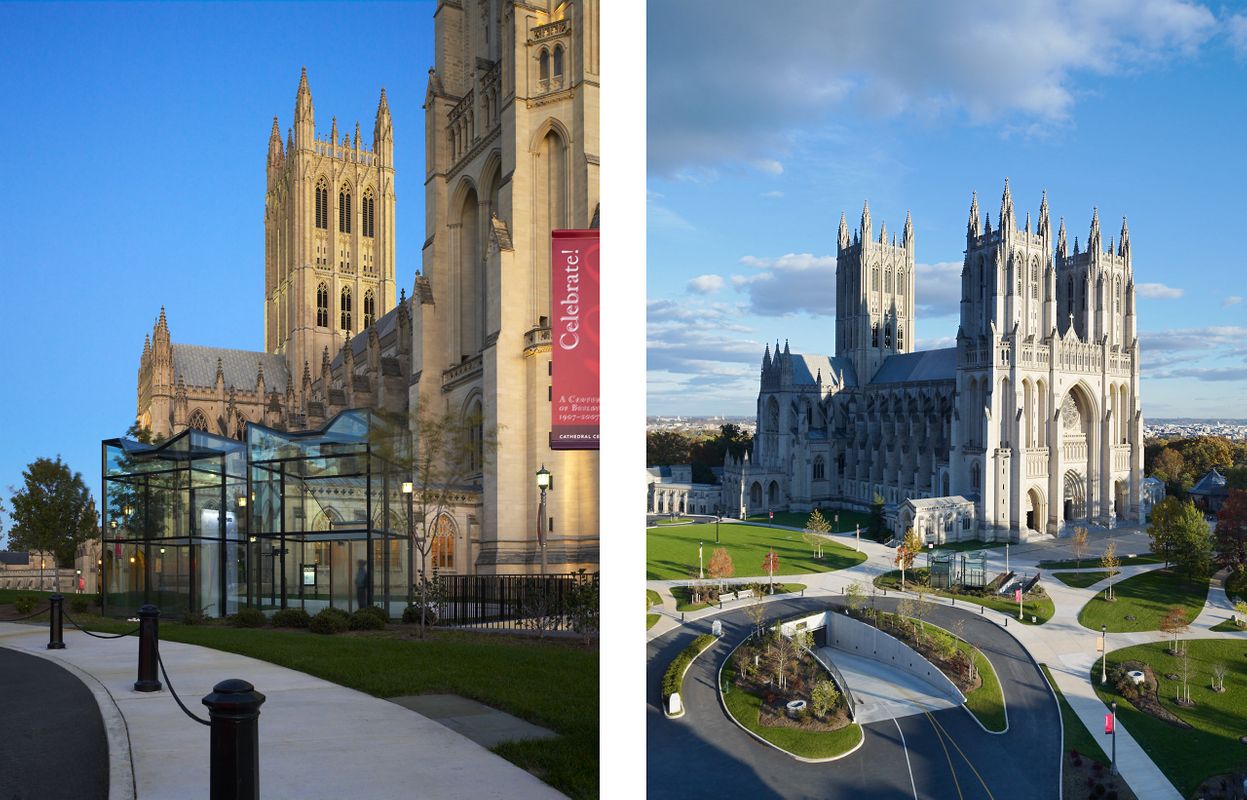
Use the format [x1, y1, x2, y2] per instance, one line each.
[0, 2, 434, 535]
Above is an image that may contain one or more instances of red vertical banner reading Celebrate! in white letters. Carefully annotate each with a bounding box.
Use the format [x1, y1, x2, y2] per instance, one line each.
[550, 229, 601, 450]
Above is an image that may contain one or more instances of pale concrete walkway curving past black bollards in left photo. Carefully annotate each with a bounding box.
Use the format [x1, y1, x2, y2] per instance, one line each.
[0, 623, 562, 800]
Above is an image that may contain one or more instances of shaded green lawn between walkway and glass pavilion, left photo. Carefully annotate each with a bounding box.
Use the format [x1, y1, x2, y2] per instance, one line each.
[41, 617, 599, 799]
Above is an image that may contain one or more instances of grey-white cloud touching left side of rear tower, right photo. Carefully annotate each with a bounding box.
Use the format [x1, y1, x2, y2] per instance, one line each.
[732, 253, 835, 317]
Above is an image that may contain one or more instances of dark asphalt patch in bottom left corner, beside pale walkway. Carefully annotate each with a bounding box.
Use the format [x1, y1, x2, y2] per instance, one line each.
[0, 634, 108, 800]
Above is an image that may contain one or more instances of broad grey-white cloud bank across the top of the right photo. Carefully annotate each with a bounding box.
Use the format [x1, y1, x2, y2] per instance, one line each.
[647, 0, 1217, 176]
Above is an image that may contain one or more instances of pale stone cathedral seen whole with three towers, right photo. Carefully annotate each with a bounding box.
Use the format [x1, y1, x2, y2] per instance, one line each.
[723, 181, 1143, 542]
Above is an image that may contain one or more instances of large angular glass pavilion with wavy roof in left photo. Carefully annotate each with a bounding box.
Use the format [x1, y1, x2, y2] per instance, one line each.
[101, 410, 409, 617]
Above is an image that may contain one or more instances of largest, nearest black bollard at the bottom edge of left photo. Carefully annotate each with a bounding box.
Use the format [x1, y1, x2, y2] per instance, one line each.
[203, 678, 264, 800]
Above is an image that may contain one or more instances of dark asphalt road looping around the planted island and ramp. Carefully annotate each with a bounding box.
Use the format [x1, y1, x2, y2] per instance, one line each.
[646, 597, 1061, 800]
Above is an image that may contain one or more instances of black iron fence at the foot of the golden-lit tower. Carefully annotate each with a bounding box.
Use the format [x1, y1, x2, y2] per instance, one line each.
[436, 572, 597, 633]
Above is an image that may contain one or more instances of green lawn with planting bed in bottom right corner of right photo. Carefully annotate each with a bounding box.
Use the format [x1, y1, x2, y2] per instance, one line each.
[1090, 639, 1247, 798]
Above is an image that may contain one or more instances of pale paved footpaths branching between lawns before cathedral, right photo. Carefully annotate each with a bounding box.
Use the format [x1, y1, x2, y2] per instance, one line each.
[648, 526, 1232, 800]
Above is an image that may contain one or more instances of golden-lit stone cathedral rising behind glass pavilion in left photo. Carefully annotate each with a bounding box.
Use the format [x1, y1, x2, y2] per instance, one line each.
[136, 0, 601, 573]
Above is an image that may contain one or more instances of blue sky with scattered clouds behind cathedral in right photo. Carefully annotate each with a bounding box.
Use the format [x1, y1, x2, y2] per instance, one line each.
[647, 0, 1247, 417]
